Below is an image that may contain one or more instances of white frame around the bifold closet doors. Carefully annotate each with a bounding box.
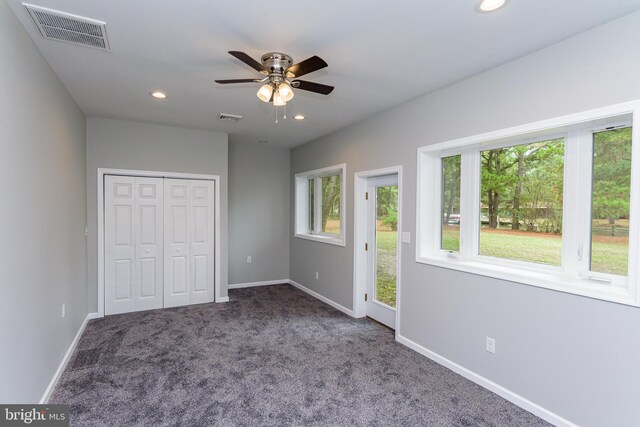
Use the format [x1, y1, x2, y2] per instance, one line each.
[97, 168, 226, 317]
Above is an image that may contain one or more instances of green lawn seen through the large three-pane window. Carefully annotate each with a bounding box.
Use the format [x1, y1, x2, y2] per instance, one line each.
[442, 226, 629, 275]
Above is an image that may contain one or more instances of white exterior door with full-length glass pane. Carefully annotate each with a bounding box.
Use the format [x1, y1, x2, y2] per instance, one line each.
[366, 175, 398, 329]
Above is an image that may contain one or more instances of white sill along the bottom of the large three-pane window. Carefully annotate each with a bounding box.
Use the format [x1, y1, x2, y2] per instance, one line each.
[416, 255, 640, 307]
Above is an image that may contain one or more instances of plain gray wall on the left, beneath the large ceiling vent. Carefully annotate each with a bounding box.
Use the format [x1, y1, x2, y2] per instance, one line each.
[0, 1, 87, 403]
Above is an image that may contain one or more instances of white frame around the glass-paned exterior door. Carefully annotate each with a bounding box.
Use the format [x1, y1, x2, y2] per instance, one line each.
[353, 166, 403, 338]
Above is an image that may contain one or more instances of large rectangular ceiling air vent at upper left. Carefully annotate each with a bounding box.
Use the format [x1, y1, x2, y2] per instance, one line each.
[22, 3, 109, 50]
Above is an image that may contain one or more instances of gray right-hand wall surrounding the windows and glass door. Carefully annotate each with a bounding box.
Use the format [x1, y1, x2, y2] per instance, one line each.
[290, 13, 640, 426]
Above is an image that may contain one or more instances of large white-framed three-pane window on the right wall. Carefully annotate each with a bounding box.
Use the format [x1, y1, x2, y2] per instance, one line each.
[416, 103, 640, 305]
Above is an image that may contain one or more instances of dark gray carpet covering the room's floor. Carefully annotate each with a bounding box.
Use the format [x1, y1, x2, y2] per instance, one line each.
[51, 285, 548, 426]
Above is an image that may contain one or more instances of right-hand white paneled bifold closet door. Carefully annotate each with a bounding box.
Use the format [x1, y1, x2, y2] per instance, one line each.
[164, 179, 214, 307]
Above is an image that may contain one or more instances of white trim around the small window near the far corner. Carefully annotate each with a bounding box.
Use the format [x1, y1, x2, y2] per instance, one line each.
[294, 163, 347, 247]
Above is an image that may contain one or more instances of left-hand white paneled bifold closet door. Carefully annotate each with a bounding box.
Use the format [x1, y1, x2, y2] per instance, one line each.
[104, 176, 164, 314]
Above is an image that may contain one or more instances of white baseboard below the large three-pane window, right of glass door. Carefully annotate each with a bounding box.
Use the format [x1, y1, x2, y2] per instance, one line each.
[397, 334, 577, 427]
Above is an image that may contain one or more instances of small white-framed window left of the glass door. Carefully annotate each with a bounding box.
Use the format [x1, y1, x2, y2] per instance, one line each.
[295, 164, 346, 246]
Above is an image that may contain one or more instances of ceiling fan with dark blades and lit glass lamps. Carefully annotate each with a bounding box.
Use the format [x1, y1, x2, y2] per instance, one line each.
[216, 50, 333, 107]
